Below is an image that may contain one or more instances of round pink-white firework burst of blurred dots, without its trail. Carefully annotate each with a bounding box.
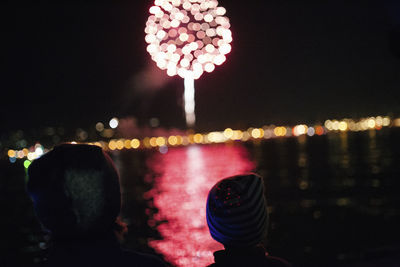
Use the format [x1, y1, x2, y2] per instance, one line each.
[145, 0, 233, 79]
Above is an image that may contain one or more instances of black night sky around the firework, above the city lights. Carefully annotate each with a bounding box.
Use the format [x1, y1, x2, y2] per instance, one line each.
[0, 0, 400, 132]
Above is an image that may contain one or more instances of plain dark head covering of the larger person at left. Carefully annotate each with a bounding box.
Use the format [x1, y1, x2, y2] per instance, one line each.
[27, 144, 121, 238]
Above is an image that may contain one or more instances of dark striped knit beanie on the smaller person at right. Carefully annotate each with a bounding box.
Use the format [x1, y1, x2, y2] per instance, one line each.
[206, 173, 268, 247]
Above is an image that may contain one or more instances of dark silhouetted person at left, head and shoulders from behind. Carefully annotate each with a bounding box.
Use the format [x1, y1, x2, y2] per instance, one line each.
[27, 144, 165, 267]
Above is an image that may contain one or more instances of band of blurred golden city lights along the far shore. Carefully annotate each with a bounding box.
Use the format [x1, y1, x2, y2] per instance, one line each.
[6, 116, 400, 161]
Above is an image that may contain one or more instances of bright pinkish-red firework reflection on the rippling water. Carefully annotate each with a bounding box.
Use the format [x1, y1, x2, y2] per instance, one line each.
[147, 145, 254, 266]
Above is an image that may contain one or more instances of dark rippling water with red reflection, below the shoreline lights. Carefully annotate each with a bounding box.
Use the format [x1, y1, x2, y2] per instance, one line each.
[0, 129, 400, 266]
